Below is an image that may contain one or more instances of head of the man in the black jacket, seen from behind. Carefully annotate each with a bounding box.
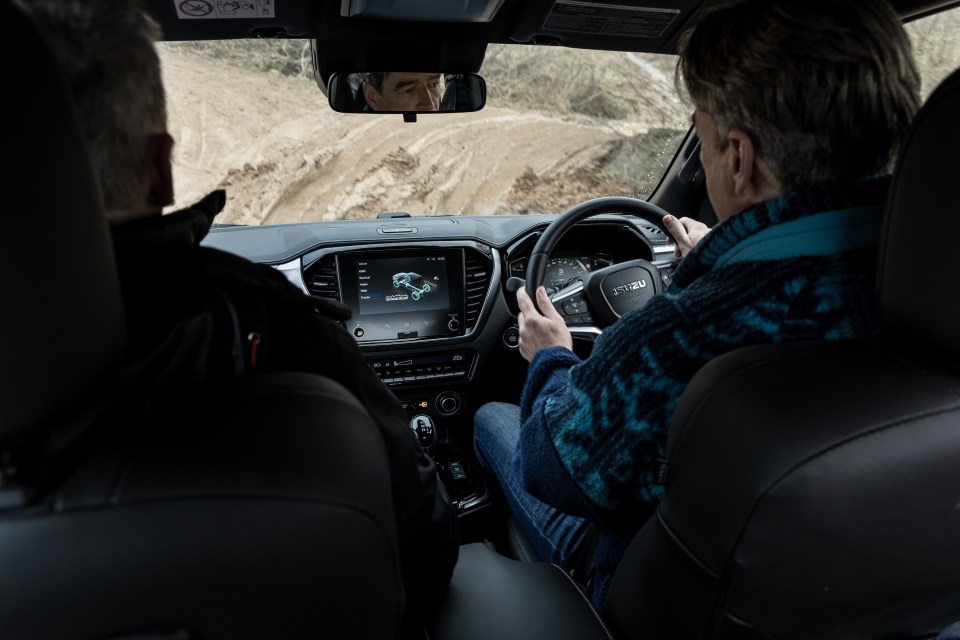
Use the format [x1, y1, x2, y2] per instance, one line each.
[17, 0, 167, 218]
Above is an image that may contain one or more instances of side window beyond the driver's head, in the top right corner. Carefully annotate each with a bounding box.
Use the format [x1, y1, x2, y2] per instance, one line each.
[906, 7, 960, 100]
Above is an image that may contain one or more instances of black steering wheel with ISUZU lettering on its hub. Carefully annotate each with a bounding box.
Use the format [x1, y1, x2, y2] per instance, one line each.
[507, 196, 670, 329]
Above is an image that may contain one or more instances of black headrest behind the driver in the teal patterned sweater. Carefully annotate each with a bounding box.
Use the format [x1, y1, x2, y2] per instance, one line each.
[877, 70, 960, 360]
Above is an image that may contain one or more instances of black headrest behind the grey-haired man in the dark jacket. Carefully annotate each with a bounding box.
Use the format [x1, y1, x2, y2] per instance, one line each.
[0, 0, 126, 446]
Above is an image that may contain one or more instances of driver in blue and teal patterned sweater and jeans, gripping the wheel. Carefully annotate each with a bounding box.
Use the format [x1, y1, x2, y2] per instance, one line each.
[474, 0, 920, 606]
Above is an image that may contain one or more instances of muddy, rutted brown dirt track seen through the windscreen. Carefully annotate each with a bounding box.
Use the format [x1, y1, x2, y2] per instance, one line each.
[162, 51, 668, 224]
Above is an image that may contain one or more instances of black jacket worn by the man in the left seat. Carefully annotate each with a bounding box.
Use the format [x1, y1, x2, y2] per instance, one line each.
[113, 191, 459, 613]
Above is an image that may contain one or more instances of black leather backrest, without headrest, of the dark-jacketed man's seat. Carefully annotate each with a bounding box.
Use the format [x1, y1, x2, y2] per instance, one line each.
[0, 373, 404, 640]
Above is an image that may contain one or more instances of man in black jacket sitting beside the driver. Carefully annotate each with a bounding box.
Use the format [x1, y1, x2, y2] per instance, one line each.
[21, 0, 459, 621]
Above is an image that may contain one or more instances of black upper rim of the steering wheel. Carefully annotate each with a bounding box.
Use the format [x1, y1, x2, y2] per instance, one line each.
[524, 196, 672, 304]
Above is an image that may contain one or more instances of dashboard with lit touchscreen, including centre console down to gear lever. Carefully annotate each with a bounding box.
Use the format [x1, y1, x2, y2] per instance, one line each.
[203, 214, 677, 512]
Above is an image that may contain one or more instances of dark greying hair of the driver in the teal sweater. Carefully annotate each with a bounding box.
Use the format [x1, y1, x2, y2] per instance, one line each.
[677, 0, 920, 192]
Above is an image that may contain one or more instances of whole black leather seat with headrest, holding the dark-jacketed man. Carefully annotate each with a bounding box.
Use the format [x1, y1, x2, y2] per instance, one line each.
[0, 0, 404, 640]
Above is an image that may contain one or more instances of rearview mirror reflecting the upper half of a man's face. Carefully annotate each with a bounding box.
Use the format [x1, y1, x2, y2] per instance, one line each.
[327, 71, 487, 113]
